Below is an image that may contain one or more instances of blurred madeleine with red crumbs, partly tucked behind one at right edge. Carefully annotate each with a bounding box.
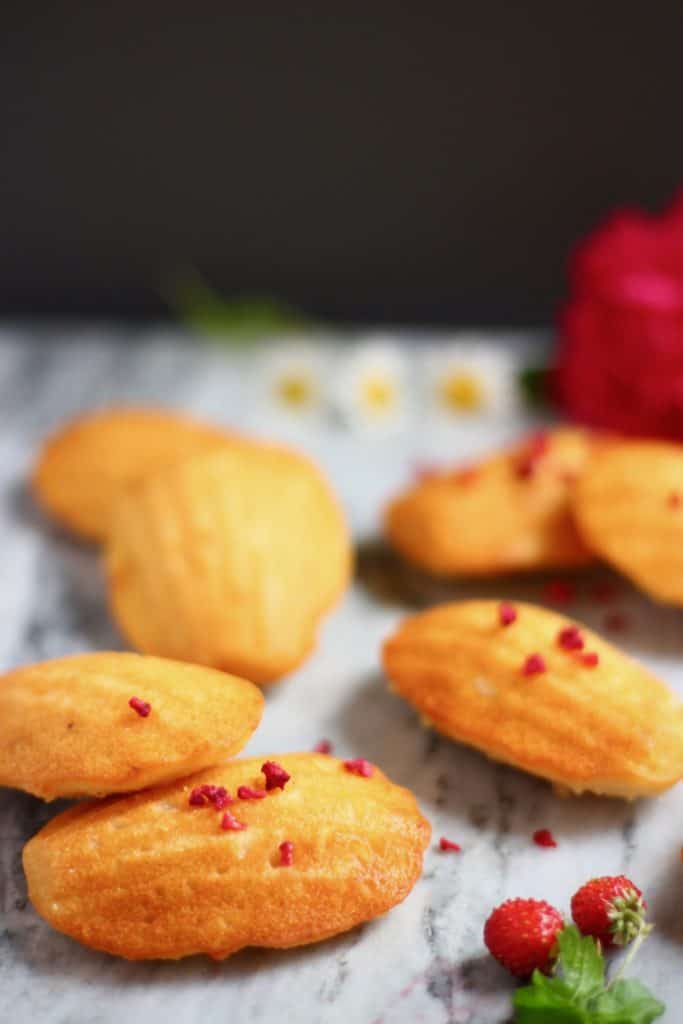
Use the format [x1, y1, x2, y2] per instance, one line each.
[385, 429, 591, 575]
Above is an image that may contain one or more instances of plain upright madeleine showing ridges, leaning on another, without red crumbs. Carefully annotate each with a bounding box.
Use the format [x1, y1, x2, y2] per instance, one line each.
[106, 441, 351, 683]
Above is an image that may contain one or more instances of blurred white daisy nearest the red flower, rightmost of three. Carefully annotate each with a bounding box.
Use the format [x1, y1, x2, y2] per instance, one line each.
[425, 338, 519, 419]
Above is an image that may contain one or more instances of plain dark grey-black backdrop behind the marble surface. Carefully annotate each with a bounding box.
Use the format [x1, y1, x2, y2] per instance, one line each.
[0, 0, 683, 324]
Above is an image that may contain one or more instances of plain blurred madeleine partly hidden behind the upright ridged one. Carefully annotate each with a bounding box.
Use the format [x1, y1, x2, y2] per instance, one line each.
[33, 407, 228, 541]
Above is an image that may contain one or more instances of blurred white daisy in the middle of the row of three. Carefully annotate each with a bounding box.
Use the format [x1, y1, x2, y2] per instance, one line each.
[333, 338, 407, 428]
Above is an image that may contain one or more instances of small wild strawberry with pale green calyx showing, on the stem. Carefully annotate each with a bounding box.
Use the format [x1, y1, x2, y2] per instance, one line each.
[571, 874, 647, 949]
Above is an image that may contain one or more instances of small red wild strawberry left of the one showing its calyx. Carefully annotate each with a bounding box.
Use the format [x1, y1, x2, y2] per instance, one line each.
[483, 899, 564, 978]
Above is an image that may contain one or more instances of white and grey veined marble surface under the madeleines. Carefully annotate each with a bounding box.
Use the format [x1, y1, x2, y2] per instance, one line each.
[0, 329, 683, 1024]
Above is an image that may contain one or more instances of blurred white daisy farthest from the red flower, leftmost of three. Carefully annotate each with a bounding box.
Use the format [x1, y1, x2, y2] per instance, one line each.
[254, 341, 326, 419]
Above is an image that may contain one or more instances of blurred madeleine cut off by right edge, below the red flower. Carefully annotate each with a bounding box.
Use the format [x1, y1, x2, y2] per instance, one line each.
[574, 440, 683, 604]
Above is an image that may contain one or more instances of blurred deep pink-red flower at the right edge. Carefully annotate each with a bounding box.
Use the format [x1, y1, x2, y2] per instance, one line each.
[555, 190, 683, 440]
